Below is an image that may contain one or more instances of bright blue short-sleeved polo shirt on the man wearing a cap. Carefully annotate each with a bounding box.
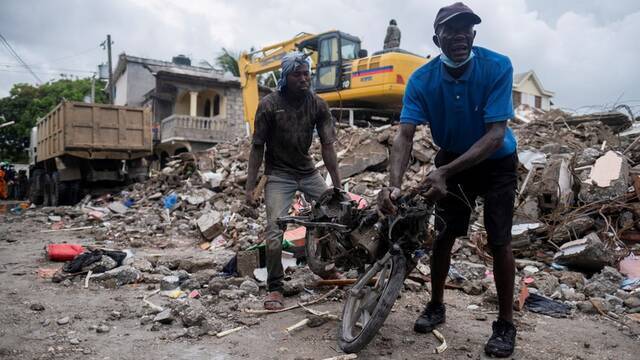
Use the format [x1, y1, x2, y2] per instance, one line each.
[400, 46, 516, 159]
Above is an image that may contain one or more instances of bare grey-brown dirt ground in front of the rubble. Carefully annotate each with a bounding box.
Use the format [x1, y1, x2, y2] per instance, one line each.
[0, 204, 640, 360]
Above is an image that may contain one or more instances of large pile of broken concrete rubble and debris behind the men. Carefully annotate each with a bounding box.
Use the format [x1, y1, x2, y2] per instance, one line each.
[33, 104, 640, 337]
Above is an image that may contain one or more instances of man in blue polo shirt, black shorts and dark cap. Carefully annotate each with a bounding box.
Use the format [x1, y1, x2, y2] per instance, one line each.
[378, 2, 518, 357]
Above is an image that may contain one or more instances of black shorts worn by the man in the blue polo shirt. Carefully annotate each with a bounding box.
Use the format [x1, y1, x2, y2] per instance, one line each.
[434, 150, 518, 247]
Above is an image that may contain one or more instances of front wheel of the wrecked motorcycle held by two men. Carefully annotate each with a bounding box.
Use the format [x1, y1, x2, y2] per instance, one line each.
[338, 253, 406, 353]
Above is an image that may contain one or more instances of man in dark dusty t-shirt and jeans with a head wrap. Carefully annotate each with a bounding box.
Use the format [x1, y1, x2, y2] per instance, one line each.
[246, 52, 341, 310]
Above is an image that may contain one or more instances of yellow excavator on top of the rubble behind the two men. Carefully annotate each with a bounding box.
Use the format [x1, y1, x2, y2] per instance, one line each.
[238, 30, 429, 132]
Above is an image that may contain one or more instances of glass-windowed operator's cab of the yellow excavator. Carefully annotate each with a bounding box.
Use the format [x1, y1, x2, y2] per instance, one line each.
[298, 31, 367, 93]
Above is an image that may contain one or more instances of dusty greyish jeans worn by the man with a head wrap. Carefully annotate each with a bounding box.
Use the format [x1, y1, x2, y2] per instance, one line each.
[265, 173, 328, 291]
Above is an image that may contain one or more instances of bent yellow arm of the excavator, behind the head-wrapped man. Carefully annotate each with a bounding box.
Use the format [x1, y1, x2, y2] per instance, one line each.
[238, 33, 316, 133]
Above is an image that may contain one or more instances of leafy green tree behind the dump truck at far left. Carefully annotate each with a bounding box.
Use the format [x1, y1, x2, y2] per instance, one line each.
[0, 78, 107, 162]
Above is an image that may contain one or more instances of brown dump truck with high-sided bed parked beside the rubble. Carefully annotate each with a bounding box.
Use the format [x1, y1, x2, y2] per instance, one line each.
[30, 101, 153, 206]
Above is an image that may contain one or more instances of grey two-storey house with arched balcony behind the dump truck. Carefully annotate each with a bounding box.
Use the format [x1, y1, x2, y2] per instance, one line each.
[113, 54, 251, 159]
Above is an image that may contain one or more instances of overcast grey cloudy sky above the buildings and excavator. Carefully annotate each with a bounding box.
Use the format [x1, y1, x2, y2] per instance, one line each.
[0, 0, 640, 109]
